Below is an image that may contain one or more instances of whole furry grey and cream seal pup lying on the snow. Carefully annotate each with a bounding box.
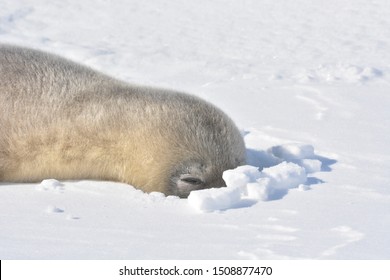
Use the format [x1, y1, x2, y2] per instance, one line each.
[0, 45, 245, 198]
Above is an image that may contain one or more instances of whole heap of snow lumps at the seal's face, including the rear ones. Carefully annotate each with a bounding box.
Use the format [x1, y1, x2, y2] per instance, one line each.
[188, 143, 322, 212]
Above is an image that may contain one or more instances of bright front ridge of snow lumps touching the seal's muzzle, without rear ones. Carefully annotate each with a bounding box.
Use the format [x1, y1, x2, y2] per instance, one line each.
[188, 162, 307, 212]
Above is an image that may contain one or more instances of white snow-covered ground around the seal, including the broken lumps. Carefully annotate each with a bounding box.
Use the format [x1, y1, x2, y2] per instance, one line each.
[0, 0, 390, 259]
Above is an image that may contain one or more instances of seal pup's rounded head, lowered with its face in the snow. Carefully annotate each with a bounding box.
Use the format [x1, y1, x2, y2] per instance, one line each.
[122, 92, 246, 198]
